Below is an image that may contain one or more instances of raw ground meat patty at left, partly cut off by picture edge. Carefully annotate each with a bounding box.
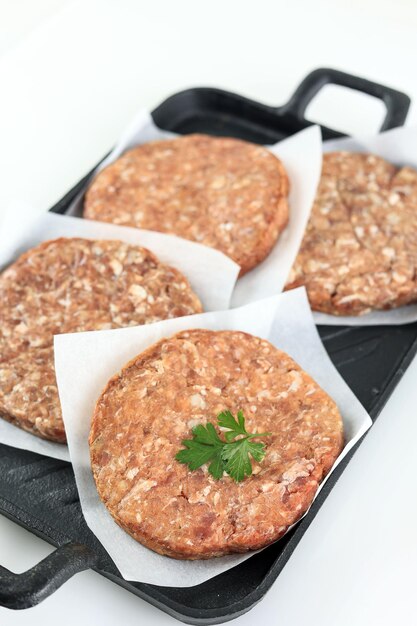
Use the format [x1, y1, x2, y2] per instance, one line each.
[0, 239, 202, 442]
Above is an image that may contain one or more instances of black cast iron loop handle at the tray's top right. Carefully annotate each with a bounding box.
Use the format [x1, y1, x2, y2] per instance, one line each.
[285, 68, 410, 130]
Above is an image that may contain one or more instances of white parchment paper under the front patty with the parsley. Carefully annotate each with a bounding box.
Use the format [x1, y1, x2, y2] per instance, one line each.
[55, 288, 371, 587]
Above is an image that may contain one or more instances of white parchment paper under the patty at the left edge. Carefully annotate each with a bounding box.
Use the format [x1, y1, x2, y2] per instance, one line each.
[0, 204, 239, 460]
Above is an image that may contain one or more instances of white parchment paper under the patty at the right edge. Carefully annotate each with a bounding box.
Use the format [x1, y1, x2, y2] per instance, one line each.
[314, 126, 417, 326]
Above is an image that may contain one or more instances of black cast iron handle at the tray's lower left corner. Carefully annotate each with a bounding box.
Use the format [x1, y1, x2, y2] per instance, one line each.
[0, 543, 98, 609]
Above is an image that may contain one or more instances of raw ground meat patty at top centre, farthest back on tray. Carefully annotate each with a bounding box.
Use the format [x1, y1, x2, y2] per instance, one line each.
[84, 135, 289, 274]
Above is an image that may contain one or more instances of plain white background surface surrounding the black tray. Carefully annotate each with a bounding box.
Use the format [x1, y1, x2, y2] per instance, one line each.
[0, 0, 417, 626]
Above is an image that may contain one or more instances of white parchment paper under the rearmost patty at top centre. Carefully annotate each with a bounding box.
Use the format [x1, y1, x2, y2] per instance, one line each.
[69, 111, 322, 307]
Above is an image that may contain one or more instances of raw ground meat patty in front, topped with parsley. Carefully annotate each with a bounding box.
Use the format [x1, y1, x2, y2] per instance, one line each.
[90, 330, 343, 559]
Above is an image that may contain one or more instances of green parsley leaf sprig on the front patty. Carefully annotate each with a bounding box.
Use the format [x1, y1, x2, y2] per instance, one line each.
[175, 411, 271, 482]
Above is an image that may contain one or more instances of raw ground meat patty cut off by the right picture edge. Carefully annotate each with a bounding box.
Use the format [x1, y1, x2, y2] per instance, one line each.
[287, 152, 417, 315]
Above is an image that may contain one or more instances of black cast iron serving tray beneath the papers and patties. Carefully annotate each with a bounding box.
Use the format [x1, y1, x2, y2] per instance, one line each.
[0, 69, 417, 624]
